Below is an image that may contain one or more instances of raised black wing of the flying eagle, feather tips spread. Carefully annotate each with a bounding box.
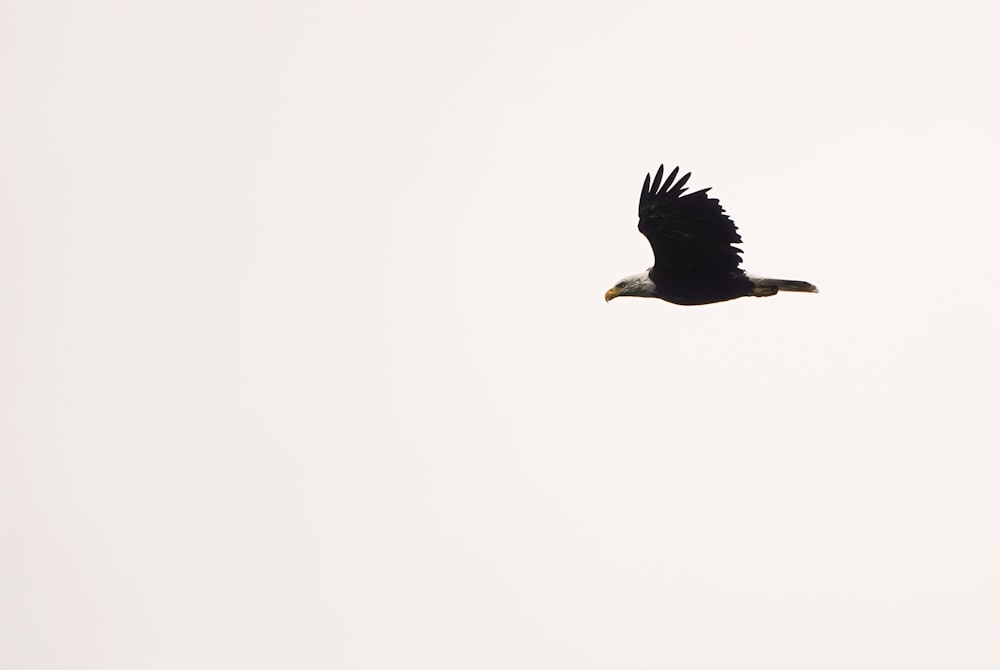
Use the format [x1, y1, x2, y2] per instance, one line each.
[639, 165, 743, 285]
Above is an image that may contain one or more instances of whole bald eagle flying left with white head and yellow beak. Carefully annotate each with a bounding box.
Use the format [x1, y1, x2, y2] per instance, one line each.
[604, 165, 817, 305]
